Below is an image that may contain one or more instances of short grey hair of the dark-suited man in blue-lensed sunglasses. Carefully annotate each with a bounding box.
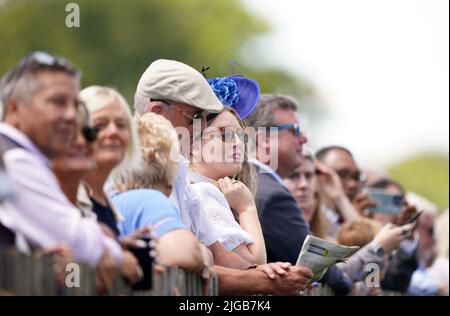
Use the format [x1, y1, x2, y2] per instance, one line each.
[245, 94, 298, 128]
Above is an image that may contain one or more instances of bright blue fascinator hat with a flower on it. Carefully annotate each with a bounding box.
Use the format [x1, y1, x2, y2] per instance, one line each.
[208, 75, 260, 120]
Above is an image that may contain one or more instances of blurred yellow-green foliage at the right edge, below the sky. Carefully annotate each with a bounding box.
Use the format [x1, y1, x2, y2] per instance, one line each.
[389, 153, 449, 210]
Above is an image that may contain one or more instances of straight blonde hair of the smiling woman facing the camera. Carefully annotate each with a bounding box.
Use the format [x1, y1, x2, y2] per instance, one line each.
[79, 86, 139, 168]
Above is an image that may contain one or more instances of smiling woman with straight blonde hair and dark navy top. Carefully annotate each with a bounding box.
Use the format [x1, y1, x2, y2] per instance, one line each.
[78, 86, 138, 236]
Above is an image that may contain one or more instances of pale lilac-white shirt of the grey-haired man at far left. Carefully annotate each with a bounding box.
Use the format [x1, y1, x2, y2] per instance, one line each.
[0, 123, 122, 265]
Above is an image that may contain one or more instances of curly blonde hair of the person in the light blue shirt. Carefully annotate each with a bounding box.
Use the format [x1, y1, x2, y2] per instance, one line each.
[113, 112, 179, 192]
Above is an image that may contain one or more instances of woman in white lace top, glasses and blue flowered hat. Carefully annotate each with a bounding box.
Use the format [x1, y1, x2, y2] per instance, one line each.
[189, 76, 272, 264]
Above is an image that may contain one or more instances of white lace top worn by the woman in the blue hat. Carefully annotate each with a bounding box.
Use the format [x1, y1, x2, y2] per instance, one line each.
[192, 182, 253, 251]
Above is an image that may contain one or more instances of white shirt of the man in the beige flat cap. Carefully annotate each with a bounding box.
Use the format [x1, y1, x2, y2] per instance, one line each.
[169, 159, 219, 246]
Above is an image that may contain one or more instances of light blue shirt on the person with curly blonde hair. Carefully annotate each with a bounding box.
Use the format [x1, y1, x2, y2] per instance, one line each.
[111, 189, 185, 237]
